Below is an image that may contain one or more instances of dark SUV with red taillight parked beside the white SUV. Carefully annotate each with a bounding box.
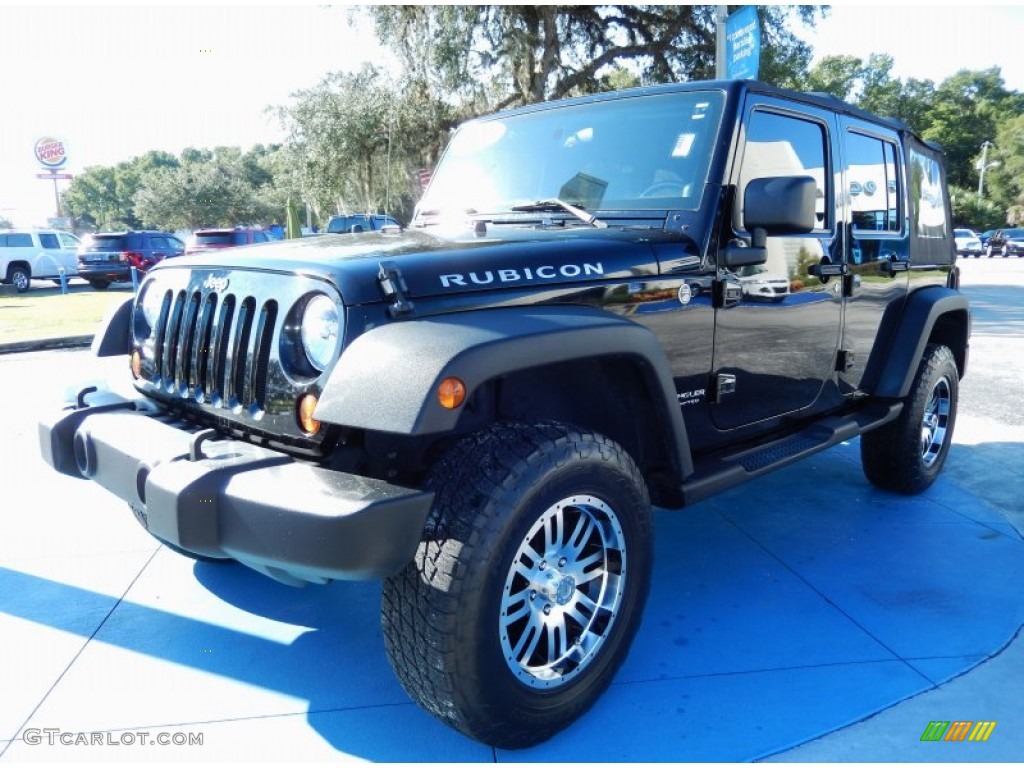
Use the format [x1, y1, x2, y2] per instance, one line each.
[78, 230, 185, 291]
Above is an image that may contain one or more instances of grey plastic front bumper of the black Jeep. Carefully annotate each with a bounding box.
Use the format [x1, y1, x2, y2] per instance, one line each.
[39, 393, 433, 584]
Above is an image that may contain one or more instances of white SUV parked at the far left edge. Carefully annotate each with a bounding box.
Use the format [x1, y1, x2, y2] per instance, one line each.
[0, 229, 79, 293]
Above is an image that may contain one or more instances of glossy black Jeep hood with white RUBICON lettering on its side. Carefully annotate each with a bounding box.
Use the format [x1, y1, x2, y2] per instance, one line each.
[152, 226, 678, 306]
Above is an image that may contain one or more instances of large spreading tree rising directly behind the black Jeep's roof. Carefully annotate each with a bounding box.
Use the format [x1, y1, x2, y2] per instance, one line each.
[367, 5, 825, 111]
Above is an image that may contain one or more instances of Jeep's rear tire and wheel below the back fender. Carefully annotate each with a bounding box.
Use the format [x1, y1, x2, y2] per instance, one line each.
[860, 344, 959, 495]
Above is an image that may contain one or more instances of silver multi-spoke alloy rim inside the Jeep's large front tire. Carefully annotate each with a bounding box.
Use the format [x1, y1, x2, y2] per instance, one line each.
[499, 496, 627, 688]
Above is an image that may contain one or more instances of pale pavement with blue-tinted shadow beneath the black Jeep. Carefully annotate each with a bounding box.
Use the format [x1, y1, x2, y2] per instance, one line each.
[0, 259, 1024, 763]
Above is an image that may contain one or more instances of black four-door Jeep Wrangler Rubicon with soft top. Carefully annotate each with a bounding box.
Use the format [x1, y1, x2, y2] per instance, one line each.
[40, 81, 970, 748]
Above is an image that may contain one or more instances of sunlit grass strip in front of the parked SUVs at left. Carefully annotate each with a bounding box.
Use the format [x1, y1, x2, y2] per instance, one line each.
[0, 281, 132, 344]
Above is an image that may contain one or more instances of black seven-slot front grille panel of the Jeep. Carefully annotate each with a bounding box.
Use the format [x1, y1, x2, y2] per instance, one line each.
[132, 265, 340, 446]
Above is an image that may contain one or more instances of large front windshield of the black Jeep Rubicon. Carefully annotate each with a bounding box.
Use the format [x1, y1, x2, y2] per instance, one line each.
[419, 91, 724, 222]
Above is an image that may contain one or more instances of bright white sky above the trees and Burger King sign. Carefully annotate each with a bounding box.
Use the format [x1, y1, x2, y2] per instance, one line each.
[0, 0, 1024, 226]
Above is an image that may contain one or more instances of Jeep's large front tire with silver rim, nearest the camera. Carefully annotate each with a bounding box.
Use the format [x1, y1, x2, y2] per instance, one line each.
[382, 424, 652, 749]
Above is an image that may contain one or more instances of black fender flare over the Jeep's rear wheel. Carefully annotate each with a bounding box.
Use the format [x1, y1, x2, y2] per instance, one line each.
[865, 286, 971, 398]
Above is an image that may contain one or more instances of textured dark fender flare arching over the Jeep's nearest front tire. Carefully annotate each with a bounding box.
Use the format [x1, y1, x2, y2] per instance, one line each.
[313, 306, 692, 476]
